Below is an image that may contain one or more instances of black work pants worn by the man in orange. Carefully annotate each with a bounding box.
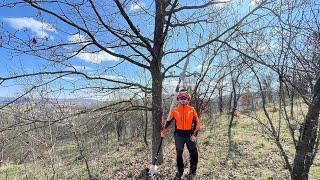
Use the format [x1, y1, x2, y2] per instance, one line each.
[174, 136, 198, 174]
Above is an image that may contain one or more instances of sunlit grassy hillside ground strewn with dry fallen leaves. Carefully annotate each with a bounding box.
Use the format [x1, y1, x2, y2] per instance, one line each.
[0, 112, 320, 180]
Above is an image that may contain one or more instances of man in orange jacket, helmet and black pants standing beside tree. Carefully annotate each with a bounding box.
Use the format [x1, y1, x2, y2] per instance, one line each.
[161, 90, 200, 180]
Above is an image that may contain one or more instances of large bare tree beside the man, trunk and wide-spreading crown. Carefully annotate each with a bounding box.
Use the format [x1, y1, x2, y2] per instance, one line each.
[0, 0, 268, 163]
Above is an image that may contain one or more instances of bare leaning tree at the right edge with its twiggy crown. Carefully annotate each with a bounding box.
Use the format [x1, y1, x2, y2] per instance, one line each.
[215, 1, 320, 179]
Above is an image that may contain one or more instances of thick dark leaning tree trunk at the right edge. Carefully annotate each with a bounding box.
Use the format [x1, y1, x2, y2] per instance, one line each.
[291, 77, 320, 180]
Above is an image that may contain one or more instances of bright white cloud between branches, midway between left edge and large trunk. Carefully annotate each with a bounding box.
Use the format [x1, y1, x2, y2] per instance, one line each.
[77, 49, 119, 64]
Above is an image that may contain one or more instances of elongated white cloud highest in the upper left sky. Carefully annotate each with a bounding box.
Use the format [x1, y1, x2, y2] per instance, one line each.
[4, 17, 57, 38]
